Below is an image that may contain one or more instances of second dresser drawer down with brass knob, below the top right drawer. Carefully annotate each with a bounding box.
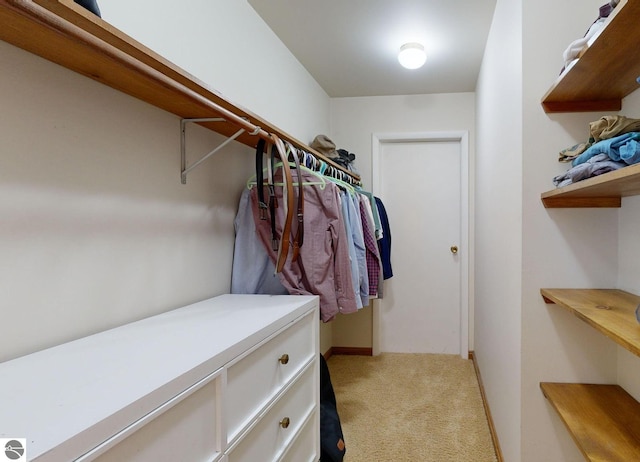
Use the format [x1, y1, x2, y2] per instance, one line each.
[228, 359, 319, 462]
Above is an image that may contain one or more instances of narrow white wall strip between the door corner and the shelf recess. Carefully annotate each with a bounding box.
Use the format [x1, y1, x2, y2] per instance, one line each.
[475, 0, 520, 462]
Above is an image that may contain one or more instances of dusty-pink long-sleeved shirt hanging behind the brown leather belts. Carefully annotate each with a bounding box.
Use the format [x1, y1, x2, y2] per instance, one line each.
[250, 169, 358, 322]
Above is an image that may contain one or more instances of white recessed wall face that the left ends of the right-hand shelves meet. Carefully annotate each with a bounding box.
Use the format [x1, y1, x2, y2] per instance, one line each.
[522, 0, 619, 461]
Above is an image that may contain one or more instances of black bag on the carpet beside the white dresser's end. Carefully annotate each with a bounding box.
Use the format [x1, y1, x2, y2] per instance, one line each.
[320, 355, 347, 462]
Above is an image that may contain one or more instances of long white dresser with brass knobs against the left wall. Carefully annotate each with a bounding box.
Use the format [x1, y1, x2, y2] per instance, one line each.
[0, 295, 320, 462]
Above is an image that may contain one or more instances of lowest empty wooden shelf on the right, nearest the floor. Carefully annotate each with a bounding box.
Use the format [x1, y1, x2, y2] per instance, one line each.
[540, 382, 640, 462]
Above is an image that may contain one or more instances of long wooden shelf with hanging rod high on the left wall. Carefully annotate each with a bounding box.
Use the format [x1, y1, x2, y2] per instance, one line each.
[0, 0, 360, 180]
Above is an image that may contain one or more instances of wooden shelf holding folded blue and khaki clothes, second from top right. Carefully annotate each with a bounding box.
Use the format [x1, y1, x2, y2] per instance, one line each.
[541, 162, 640, 208]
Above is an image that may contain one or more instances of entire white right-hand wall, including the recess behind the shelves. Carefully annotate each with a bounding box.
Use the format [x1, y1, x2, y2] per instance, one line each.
[476, 0, 640, 462]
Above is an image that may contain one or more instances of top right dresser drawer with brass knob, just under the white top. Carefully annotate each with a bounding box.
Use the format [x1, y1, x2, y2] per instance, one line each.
[225, 311, 317, 444]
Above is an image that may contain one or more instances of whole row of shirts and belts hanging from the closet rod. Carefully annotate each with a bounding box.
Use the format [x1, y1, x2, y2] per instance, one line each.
[231, 135, 391, 322]
